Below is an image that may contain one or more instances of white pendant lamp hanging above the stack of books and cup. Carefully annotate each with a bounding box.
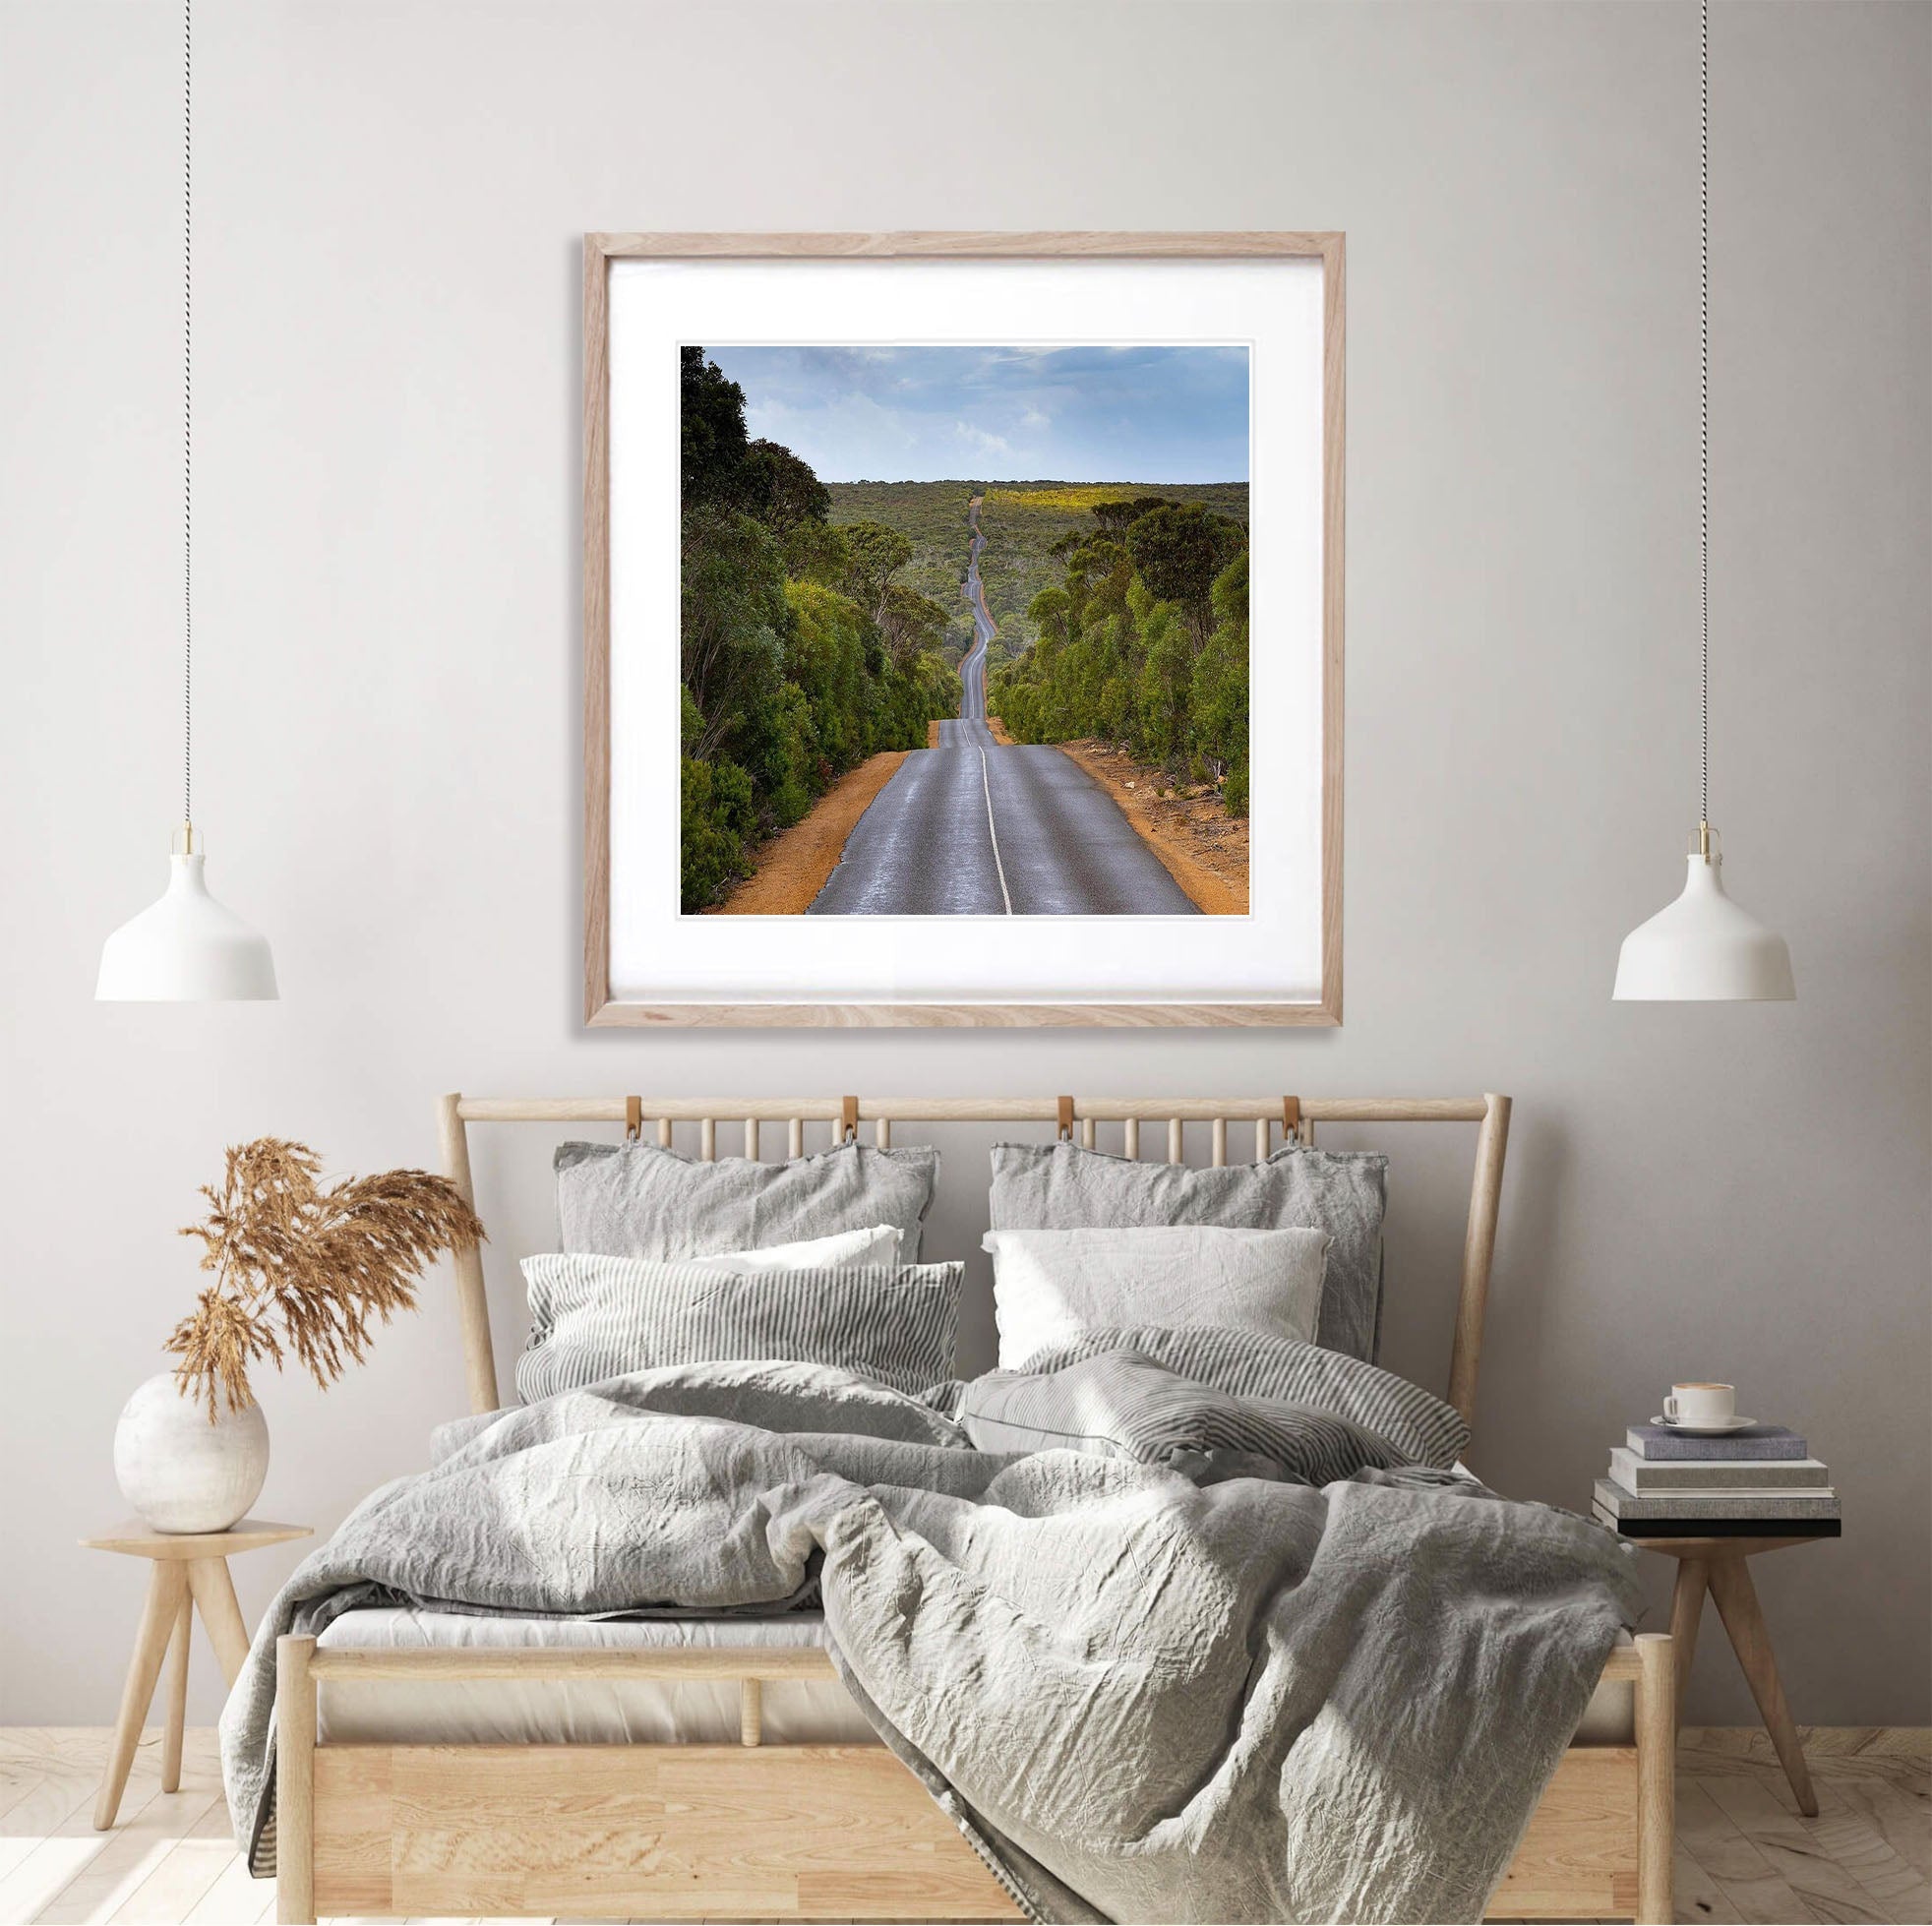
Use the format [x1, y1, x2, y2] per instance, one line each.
[1611, 0, 1797, 1002]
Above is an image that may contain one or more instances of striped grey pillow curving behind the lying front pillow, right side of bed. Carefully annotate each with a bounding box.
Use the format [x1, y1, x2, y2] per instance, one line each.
[1004, 1323, 1469, 1469]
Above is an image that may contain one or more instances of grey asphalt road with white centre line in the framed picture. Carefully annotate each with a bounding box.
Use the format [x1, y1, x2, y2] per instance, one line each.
[806, 495, 1200, 916]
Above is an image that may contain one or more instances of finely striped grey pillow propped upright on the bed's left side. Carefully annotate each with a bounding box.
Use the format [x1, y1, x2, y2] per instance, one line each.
[515, 1252, 964, 1405]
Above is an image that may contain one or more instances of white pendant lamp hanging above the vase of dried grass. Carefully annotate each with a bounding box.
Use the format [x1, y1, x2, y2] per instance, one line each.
[94, 0, 276, 1002]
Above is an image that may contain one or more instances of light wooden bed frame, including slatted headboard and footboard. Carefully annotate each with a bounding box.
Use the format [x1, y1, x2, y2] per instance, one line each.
[276, 1096, 1677, 1922]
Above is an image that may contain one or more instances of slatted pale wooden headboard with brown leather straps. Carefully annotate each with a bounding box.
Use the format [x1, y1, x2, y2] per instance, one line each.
[437, 1094, 1509, 1423]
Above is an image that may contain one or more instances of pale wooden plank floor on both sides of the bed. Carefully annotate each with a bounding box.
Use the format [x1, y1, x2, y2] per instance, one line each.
[0, 1727, 1932, 1926]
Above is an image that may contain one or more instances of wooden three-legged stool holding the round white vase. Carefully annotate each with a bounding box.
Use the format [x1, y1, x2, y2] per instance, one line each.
[81, 1519, 309, 1832]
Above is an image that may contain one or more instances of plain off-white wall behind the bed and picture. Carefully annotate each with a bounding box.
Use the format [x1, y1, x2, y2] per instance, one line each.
[0, 0, 1932, 1723]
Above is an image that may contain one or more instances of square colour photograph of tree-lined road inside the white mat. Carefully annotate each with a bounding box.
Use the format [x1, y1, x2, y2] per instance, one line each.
[680, 346, 1248, 918]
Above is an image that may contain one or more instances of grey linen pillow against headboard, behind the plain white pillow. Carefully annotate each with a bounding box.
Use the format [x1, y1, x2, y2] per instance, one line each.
[992, 1144, 1389, 1358]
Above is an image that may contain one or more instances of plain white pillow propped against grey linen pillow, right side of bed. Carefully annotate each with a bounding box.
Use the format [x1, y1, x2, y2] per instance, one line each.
[982, 1225, 1329, 1371]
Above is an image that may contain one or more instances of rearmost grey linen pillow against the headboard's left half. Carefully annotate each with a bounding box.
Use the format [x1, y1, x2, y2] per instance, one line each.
[555, 1144, 939, 1263]
